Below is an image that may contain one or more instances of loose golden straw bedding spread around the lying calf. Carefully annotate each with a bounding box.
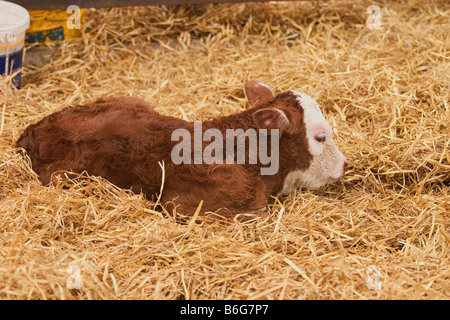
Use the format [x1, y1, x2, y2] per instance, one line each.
[0, 1, 450, 299]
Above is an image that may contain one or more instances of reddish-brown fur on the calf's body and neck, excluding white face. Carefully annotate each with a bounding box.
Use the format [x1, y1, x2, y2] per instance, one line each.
[16, 86, 311, 217]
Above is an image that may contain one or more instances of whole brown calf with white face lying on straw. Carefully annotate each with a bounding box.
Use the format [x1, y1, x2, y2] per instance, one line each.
[16, 81, 347, 217]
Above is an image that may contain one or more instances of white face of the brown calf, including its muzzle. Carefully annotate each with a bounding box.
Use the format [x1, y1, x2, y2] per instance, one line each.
[282, 91, 347, 195]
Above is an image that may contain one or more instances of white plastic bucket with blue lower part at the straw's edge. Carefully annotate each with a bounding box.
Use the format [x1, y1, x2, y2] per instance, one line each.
[0, 1, 30, 88]
